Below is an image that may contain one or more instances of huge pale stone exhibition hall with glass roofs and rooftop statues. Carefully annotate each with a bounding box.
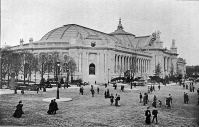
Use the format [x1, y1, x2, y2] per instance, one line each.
[11, 19, 186, 83]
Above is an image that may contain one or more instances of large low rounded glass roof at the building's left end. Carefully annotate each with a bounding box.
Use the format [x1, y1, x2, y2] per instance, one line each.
[40, 24, 118, 43]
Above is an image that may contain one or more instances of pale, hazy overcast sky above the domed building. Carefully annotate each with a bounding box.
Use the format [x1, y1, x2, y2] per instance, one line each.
[1, 0, 199, 66]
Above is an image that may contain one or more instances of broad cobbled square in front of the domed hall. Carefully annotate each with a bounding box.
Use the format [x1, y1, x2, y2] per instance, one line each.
[0, 83, 199, 127]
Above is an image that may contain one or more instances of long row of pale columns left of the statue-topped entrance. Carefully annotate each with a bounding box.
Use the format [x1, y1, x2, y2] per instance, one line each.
[114, 54, 150, 75]
